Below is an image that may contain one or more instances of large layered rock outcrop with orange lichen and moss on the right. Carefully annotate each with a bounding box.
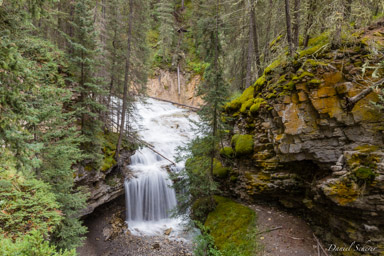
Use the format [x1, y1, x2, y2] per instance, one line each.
[222, 24, 384, 255]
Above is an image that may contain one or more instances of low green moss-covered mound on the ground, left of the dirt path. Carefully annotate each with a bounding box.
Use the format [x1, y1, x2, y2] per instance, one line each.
[205, 197, 258, 256]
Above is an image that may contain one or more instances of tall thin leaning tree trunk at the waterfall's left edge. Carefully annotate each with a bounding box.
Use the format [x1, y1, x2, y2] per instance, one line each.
[115, 0, 133, 160]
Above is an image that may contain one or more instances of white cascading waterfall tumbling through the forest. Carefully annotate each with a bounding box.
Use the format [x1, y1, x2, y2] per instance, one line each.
[125, 99, 197, 235]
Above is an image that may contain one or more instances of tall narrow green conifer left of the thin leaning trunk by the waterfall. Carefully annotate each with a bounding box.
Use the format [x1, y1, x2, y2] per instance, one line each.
[66, 0, 104, 169]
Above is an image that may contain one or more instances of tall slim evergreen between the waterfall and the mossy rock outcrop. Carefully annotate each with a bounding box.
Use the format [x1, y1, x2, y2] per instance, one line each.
[176, 0, 228, 219]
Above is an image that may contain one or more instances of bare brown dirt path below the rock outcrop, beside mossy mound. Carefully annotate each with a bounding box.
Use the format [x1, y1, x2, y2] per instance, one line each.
[249, 205, 318, 256]
